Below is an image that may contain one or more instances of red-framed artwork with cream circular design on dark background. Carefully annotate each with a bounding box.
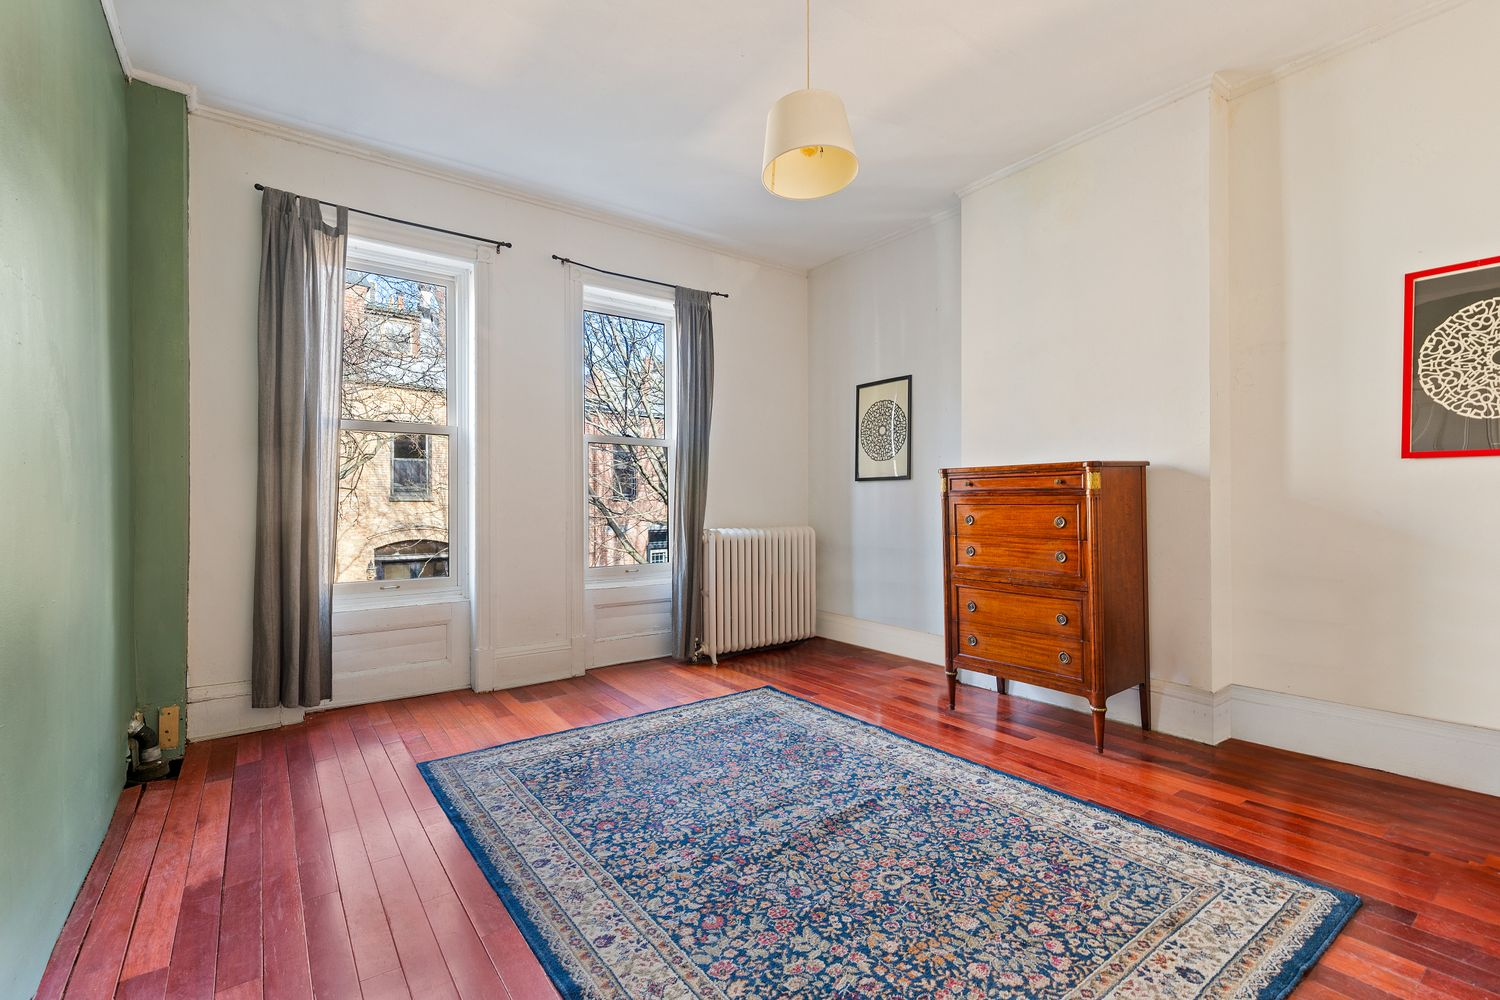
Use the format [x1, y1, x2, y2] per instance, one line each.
[1401, 256, 1500, 459]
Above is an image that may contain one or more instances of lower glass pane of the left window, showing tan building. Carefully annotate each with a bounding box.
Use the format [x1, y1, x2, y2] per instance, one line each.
[335, 430, 449, 583]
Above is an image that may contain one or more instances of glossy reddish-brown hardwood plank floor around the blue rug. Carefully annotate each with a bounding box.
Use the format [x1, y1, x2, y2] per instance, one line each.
[39, 640, 1500, 1000]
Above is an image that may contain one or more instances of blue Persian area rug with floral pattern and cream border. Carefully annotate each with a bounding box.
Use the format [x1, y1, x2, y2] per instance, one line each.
[422, 688, 1359, 1000]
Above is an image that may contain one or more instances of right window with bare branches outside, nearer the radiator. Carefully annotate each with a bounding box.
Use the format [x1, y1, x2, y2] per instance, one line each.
[582, 288, 672, 576]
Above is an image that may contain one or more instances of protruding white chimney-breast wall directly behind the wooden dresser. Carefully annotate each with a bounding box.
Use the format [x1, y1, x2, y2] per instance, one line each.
[962, 91, 1214, 709]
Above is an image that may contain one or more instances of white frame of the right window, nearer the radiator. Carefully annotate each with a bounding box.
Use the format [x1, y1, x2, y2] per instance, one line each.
[573, 274, 677, 586]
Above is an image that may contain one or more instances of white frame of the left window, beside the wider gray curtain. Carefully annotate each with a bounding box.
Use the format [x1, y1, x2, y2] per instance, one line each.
[333, 235, 476, 612]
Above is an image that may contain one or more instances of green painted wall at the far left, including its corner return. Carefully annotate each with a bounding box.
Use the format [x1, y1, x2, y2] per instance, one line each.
[0, 0, 188, 997]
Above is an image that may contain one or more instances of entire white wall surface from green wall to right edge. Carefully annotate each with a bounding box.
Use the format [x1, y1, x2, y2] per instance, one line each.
[189, 3, 1500, 787]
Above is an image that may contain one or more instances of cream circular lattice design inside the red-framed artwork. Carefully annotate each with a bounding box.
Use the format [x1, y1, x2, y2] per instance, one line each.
[1418, 298, 1500, 420]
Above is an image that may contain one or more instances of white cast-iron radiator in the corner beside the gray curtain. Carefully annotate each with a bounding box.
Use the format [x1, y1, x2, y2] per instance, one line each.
[702, 528, 818, 663]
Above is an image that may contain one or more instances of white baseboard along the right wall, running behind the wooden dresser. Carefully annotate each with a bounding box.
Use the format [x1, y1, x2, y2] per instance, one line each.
[818, 612, 1500, 795]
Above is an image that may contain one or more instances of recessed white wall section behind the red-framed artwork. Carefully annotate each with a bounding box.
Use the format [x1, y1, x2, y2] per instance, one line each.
[1229, 3, 1500, 727]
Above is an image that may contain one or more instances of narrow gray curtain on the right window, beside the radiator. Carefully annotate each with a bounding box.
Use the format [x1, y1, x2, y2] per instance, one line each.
[671, 288, 714, 660]
